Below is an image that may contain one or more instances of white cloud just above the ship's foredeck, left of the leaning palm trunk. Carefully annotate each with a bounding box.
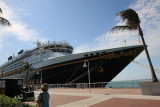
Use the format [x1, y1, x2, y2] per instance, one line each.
[75, 27, 140, 53]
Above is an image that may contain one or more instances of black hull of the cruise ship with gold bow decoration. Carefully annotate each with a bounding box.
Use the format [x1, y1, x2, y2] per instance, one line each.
[30, 46, 144, 84]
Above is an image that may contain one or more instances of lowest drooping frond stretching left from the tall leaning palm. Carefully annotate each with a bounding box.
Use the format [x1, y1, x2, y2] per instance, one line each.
[111, 26, 134, 33]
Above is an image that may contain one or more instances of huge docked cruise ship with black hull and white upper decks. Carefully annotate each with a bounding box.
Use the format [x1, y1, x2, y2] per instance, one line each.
[0, 41, 144, 84]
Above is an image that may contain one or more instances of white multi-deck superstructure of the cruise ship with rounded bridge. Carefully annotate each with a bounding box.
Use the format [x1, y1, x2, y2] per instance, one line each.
[0, 41, 73, 78]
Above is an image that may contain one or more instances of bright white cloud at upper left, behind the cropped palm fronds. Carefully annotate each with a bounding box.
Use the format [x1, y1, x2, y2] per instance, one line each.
[0, 1, 46, 50]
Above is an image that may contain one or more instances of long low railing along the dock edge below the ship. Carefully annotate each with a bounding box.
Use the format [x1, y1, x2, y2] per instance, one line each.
[32, 81, 142, 89]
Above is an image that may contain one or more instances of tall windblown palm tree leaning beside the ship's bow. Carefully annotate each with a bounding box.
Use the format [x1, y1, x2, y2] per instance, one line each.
[111, 8, 158, 82]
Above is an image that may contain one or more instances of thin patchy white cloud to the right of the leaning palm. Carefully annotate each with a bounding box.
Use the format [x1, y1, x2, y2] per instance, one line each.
[131, 0, 160, 56]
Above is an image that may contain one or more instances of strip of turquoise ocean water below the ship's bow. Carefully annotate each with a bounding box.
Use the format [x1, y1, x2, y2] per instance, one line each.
[105, 79, 151, 88]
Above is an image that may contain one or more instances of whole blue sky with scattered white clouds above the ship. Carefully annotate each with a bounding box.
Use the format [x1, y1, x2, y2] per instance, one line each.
[0, 0, 160, 80]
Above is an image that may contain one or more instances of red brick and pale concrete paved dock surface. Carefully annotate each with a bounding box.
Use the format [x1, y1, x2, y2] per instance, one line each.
[26, 88, 160, 107]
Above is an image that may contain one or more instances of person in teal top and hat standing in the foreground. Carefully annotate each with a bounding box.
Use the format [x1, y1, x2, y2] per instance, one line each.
[37, 83, 50, 107]
